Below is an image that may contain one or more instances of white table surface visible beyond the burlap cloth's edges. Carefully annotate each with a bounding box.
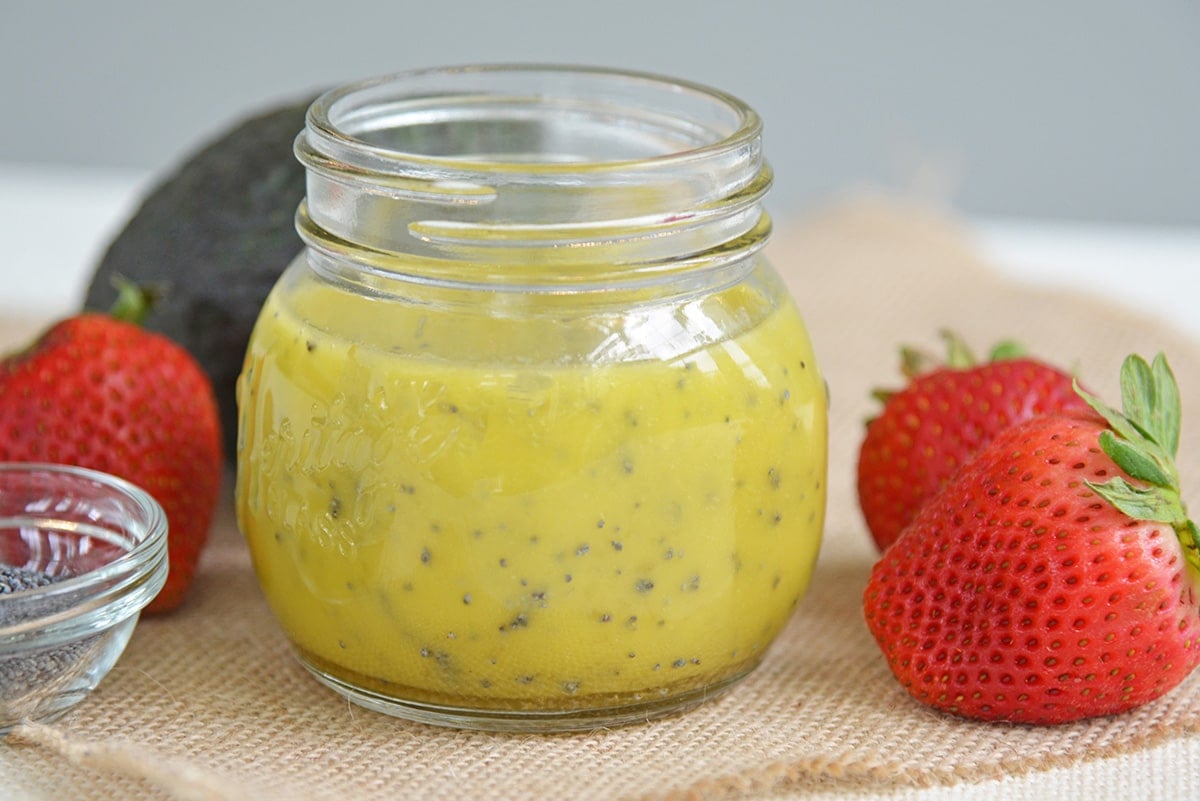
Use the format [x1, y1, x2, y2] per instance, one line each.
[0, 162, 1200, 801]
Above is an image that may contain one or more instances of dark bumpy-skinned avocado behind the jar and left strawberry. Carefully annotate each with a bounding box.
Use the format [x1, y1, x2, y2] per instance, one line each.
[84, 100, 311, 462]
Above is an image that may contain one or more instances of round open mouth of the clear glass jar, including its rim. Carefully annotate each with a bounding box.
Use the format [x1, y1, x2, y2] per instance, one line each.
[307, 65, 762, 180]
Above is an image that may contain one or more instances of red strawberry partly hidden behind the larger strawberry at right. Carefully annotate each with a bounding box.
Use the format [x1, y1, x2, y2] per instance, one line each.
[858, 333, 1087, 550]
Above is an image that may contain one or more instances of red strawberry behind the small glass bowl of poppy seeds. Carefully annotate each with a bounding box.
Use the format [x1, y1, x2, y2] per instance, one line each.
[0, 285, 222, 613]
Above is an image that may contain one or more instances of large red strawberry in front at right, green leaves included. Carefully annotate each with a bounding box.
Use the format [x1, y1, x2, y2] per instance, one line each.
[863, 356, 1200, 723]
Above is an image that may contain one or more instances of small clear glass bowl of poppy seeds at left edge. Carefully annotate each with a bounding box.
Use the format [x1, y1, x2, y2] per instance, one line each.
[0, 463, 167, 734]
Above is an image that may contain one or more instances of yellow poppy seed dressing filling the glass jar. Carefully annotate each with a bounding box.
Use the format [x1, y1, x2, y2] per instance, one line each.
[238, 272, 826, 710]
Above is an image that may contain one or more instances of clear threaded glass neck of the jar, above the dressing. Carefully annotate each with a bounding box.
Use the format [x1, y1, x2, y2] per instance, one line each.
[295, 66, 772, 289]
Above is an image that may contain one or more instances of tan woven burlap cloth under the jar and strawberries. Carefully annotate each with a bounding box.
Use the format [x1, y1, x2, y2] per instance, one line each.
[0, 198, 1200, 800]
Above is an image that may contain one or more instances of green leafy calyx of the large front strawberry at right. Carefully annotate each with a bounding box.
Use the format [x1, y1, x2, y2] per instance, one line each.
[1075, 354, 1200, 573]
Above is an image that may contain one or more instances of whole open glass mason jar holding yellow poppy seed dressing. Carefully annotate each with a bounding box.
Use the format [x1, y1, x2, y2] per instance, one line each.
[238, 66, 827, 731]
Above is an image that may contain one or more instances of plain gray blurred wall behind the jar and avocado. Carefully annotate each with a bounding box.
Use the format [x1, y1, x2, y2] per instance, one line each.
[0, 0, 1200, 225]
